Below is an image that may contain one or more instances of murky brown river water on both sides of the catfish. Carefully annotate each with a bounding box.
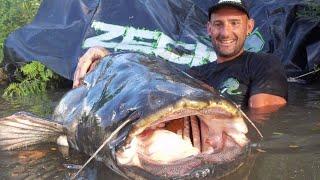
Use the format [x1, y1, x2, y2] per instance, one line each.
[0, 82, 320, 180]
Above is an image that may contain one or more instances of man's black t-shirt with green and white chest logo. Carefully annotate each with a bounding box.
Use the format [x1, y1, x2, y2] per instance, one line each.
[187, 52, 288, 106]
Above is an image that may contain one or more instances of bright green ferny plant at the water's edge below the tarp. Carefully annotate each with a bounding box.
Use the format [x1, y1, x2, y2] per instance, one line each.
[2, 61, 59, 98]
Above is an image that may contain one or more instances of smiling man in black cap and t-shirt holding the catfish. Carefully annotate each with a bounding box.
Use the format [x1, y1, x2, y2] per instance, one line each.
[74, 0, 287, 108]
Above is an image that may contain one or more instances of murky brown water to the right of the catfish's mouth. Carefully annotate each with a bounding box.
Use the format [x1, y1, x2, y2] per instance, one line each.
[249, 83, 320, 180]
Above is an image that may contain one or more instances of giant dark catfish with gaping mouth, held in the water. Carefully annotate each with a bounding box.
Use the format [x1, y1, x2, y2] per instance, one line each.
[0, 53, 250, 179]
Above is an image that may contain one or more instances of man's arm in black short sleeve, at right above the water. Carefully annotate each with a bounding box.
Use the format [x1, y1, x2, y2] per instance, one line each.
[248, 53, 288, 108]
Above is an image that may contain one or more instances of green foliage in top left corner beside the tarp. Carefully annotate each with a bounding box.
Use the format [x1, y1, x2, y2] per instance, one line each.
[0, 0, 41, 63]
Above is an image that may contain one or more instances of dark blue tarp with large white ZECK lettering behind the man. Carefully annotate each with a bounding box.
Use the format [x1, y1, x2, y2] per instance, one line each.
[3, 0, 320, 79]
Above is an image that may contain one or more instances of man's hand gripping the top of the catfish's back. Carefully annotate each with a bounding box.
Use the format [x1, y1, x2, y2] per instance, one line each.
[73, 46, 110, 88]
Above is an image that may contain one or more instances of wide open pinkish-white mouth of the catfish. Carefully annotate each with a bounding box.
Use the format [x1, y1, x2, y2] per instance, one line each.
[116, 108, 249, 177]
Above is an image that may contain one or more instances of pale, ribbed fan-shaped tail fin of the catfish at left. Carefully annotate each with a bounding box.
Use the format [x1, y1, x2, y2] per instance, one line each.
[0, 112, 64, 150]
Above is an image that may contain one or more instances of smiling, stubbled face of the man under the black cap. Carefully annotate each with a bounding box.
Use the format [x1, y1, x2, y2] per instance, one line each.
[207, 7, 254, 60]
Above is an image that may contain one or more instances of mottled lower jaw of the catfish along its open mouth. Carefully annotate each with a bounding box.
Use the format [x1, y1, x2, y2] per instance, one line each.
[131, 135, 249, 179]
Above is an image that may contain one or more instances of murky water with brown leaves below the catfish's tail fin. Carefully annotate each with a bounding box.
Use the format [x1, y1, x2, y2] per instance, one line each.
[0, 145, 124, 180]
